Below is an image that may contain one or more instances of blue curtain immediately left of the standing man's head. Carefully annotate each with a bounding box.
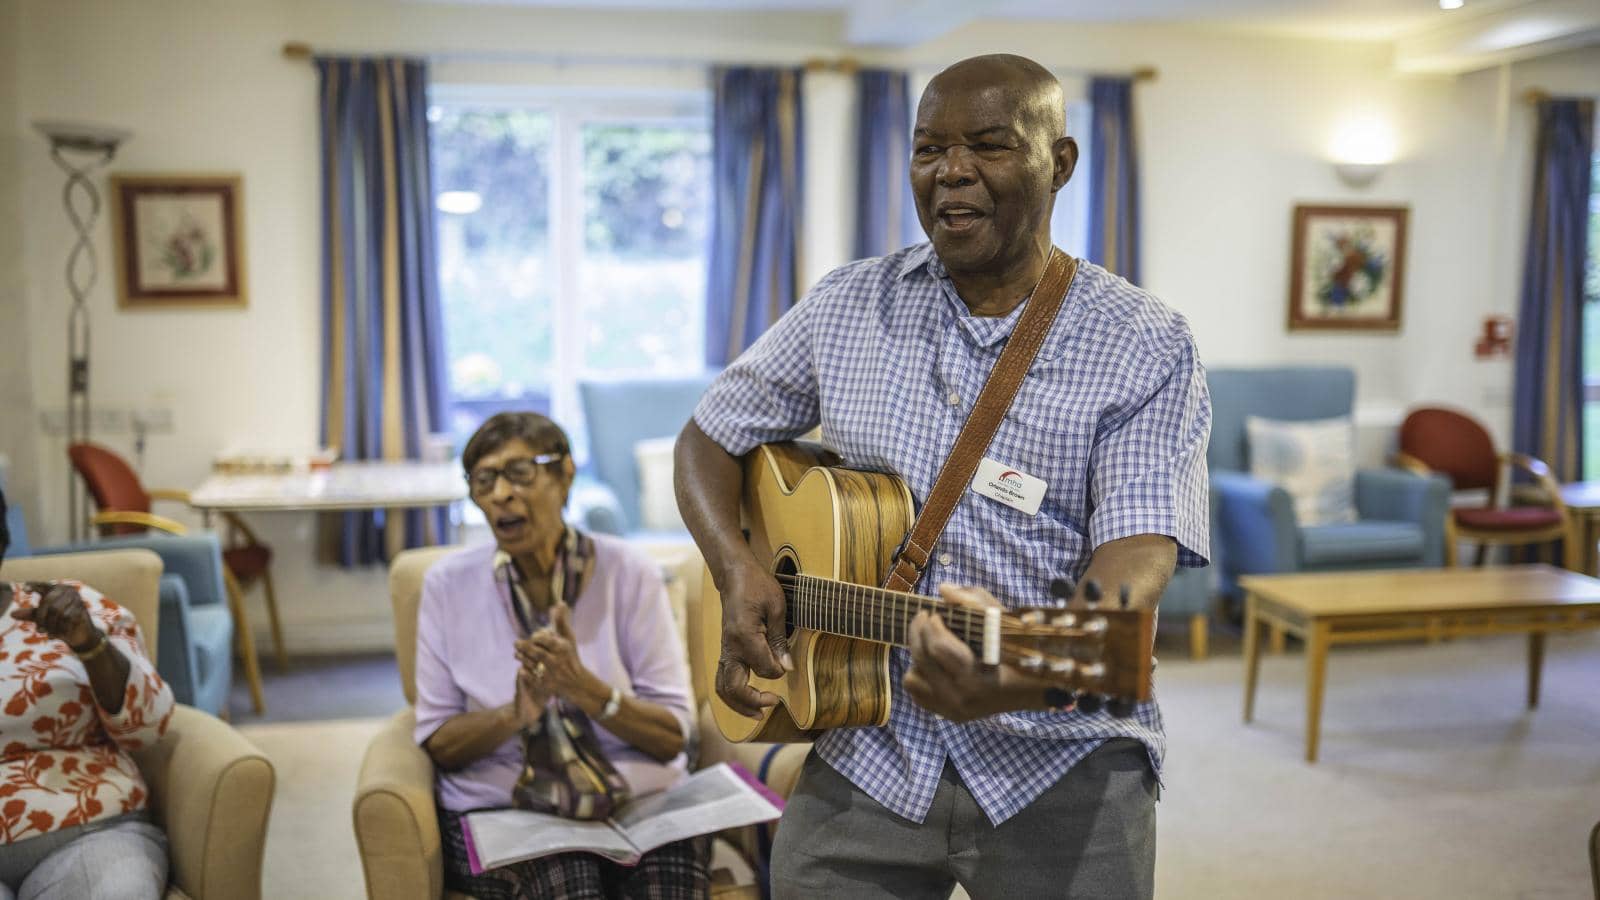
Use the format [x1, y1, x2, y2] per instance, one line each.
[854, 69, 926, 259]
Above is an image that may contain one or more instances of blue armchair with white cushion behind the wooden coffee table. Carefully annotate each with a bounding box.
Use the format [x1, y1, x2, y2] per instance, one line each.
[1206, 367, 1450, 594]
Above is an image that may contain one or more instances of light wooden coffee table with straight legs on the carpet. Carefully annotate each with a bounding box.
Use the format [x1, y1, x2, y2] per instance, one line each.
[1238, 565, 1600, 762]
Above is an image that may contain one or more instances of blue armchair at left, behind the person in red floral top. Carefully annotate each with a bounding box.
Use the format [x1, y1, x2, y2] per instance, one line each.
[28, 533, 234, 716]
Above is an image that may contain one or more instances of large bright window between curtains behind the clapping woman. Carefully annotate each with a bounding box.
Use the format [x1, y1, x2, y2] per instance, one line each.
[429, 88, 710, 458]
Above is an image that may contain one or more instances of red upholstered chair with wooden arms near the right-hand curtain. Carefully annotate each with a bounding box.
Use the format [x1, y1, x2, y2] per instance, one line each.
[1397, 408, 1581, 570]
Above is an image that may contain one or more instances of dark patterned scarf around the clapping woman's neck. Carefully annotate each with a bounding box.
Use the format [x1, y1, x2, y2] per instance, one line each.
[494, 525, 630, 818]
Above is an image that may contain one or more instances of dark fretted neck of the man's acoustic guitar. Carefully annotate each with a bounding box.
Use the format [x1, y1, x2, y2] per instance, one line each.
[779, 575, 986, 655]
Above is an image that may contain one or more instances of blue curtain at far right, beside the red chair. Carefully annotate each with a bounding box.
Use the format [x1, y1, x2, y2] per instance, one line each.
[1512, 99, 1595, 482]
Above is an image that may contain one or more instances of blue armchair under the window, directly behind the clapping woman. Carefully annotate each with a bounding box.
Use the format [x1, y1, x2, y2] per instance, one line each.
[570, 372, 717, 533]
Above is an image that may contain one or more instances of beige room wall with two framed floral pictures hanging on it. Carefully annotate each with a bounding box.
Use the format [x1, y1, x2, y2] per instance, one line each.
[12, 0, 1600, 650]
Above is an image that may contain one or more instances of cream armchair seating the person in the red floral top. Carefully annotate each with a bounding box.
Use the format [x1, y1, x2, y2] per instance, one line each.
[0, 549, 275, 900]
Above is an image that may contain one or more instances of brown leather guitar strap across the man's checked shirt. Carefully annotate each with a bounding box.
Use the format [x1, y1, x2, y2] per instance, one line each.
[883, 247, 1078, 591]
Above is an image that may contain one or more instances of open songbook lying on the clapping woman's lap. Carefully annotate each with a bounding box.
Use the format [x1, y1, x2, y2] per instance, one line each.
[462, 762, 784, 874]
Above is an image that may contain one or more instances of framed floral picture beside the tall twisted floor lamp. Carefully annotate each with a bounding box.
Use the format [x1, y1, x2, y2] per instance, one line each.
[110, 175, 248, 309]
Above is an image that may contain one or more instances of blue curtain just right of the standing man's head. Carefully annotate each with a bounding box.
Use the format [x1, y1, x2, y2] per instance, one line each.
[1088, 77, 1139, 283]
